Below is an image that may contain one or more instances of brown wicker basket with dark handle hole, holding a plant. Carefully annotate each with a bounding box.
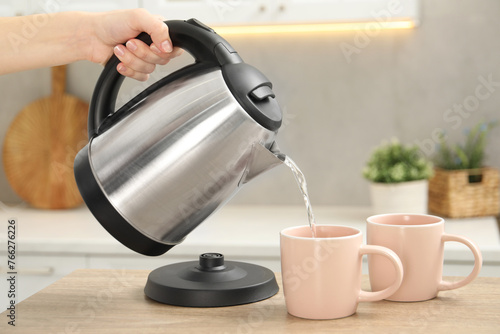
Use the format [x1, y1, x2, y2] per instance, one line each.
[429, 167, 500, 218]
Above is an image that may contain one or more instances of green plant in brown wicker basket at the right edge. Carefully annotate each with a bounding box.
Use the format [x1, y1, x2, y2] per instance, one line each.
[429, 122, 500, 218]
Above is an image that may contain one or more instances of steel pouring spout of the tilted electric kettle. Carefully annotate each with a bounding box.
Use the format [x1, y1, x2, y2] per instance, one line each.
[239, 142, 286, 185]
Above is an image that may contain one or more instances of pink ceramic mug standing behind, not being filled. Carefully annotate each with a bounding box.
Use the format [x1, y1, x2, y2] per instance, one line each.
[366, 213, 482, 302]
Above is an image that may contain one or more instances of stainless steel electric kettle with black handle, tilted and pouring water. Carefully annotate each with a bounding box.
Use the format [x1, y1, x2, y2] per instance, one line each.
[74, 19, 285, 255]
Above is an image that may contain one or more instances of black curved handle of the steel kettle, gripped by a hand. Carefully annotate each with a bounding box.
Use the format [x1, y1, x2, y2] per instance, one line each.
[88, 19, 242, 139]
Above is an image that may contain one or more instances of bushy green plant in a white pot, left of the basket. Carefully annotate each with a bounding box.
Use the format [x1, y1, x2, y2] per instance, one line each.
[363, 139, 433, 214]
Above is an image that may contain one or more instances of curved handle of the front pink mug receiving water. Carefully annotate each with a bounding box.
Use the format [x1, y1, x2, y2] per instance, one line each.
[358, 245, 403, 302]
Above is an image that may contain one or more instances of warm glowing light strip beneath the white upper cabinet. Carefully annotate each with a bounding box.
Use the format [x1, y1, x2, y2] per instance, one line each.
[212, 21, 415, 35]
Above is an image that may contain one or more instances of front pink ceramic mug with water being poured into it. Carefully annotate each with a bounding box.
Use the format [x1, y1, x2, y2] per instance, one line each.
[280, 225, 403, 319]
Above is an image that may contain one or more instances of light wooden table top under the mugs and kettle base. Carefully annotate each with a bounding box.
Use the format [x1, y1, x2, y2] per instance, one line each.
[0, 269, 500, 334]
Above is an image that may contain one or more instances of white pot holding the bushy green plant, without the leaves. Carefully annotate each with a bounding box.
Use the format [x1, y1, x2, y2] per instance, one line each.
[370, 180, 428, 215]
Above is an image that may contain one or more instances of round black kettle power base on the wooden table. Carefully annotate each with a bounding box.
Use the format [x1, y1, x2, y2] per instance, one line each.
[144, 253, 279, 307]
